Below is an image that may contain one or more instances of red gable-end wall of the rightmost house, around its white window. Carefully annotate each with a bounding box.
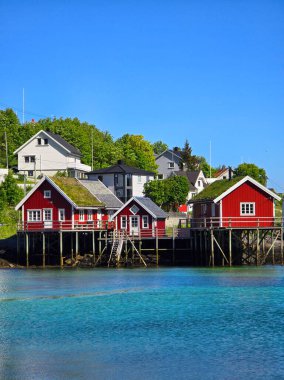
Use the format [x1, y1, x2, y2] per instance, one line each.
[222, 182, 274, 227]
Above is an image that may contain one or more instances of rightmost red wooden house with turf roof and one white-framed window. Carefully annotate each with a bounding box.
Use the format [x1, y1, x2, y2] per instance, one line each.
[190, 176, 281, 228]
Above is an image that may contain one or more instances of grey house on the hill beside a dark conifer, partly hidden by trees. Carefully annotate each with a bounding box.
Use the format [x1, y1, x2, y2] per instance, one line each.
[155, 149, 182, 179]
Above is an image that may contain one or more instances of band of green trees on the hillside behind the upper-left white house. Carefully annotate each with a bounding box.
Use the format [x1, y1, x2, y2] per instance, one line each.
[0, 109, 157, 171]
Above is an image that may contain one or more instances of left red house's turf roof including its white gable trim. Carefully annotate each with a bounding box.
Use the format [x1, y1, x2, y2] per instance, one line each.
[15, 176, 104, 210]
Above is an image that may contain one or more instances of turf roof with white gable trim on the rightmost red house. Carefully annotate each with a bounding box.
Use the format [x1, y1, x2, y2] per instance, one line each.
[188, 176, 281, 203]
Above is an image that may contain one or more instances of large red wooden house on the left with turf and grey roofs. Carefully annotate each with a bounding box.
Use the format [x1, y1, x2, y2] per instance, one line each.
[16, 176, 122, 231]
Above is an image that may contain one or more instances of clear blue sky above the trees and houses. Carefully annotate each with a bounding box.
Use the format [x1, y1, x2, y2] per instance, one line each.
[0, 0, 284, 192]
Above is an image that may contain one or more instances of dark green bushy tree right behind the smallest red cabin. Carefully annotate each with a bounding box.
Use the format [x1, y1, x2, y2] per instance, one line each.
[144, 176, 189, 211]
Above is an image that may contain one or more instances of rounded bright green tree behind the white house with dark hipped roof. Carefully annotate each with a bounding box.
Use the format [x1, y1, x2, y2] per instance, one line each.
[116, 134, 157, 172]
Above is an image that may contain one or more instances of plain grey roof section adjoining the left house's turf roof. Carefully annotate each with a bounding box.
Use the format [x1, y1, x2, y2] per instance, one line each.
[79, 179, 123, 209]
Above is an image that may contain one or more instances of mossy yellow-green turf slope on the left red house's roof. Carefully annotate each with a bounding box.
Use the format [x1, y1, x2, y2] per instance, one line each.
[51, 177, 104, 207]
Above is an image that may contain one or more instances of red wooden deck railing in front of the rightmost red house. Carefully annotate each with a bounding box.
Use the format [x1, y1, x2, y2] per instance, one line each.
[187, 216, 284, 228]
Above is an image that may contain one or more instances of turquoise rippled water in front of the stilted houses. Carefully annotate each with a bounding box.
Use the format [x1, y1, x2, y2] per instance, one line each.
[0, 267, 284, 380]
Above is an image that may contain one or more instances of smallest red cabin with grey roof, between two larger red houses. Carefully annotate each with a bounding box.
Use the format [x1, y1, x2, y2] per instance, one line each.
[113, 197, 168, 237]
